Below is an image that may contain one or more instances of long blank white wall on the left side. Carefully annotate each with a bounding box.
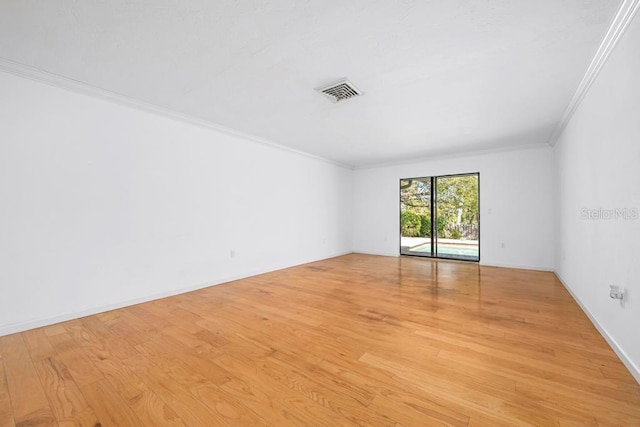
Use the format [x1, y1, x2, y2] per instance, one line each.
[0, 73, 352, 335]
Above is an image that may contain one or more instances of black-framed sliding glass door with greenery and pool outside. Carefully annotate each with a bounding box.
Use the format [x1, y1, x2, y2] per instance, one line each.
[400, 173, 480, 261]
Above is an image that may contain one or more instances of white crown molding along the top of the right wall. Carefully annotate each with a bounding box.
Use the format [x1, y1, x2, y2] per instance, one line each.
[549, 0, 640, 146]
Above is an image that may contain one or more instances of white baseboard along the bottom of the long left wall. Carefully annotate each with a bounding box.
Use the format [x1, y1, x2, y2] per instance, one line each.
[0, 251, 351, 337]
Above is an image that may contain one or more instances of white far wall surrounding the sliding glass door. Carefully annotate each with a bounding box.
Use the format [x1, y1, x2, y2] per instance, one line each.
[354, 147, 553, 270]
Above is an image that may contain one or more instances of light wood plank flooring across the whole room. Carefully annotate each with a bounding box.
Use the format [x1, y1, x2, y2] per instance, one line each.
[0, 254, 640, 427]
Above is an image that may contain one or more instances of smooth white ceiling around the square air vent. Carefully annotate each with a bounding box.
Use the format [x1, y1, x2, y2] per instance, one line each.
[0, 0, 620, 166]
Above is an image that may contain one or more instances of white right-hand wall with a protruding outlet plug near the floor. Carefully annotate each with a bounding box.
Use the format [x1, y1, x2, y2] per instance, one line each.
[555, 12, 640, 381]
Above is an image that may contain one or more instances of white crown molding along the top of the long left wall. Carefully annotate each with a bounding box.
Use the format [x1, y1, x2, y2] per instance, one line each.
[0, 58, 353, 170]
